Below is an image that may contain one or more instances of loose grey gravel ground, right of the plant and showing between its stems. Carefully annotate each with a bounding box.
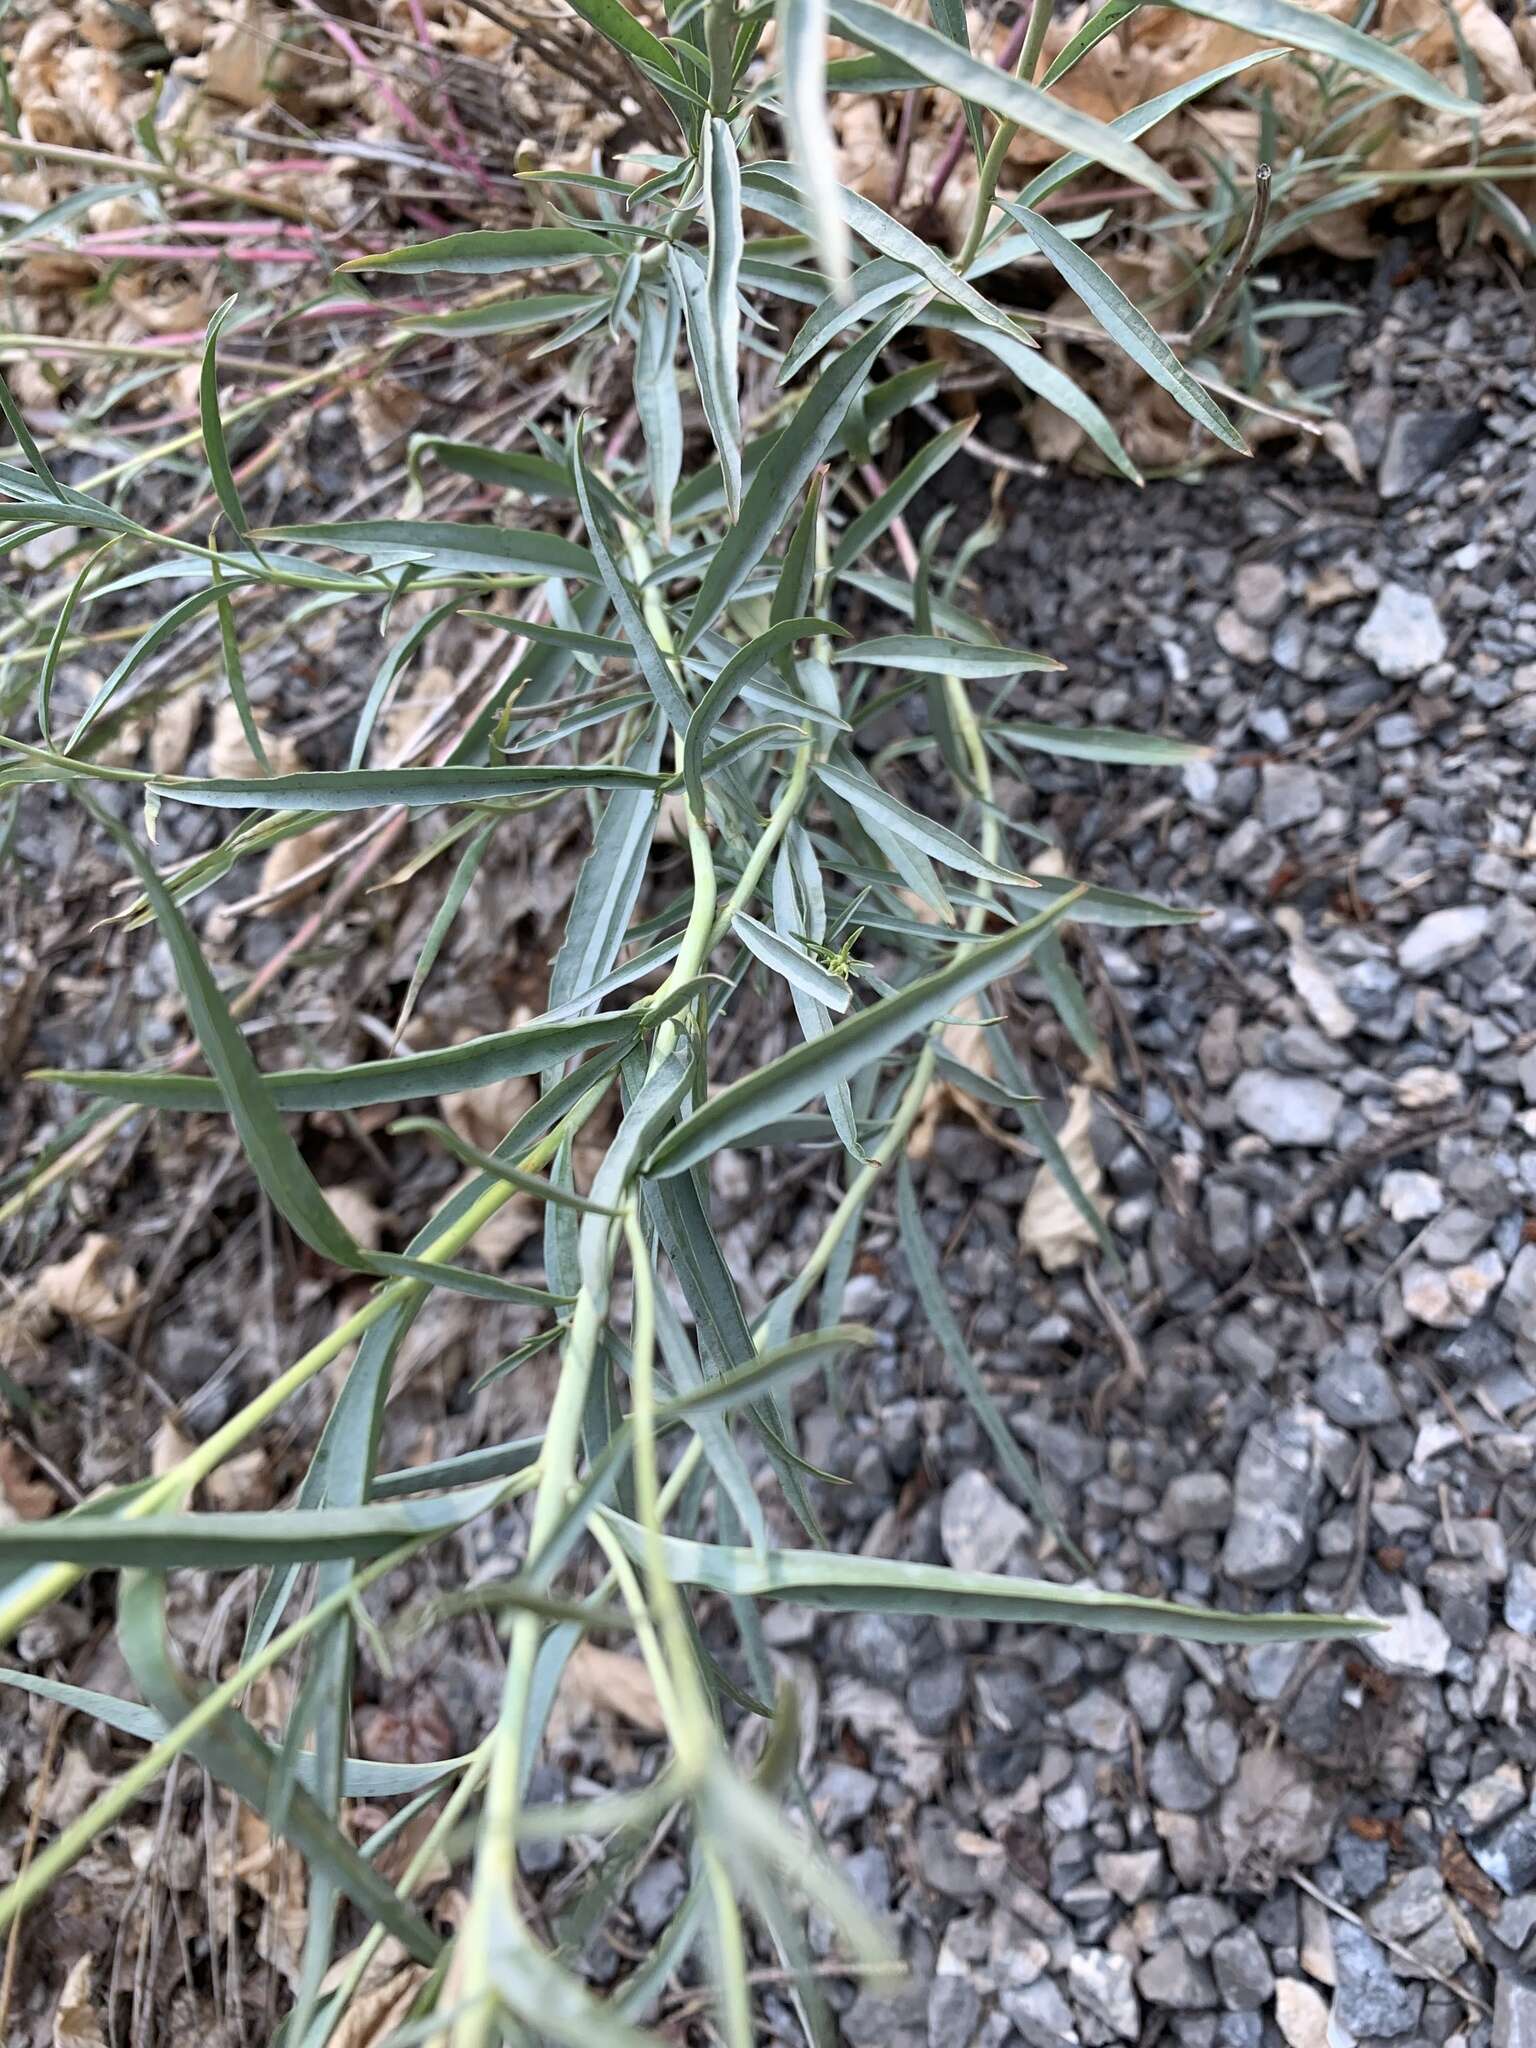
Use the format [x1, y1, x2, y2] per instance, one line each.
[4, 250, 1536, 2048]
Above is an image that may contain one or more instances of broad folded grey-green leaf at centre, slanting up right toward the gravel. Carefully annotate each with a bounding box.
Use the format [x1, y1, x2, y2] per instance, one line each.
[649, 895, 1077, 1176]
